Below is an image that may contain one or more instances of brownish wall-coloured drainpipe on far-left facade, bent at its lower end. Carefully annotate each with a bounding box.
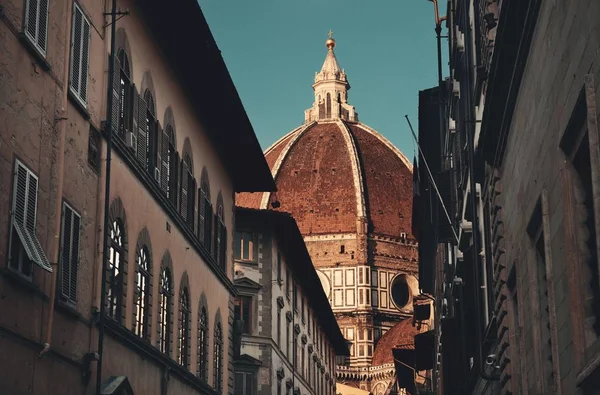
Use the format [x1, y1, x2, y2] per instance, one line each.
[39, 0, 73, 358]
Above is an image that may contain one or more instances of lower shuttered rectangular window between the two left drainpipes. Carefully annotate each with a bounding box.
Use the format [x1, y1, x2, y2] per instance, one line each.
[59, 203, 81, 304]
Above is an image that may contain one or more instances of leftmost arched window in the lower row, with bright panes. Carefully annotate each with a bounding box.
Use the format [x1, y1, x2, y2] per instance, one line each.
[106, 219, 124, 322]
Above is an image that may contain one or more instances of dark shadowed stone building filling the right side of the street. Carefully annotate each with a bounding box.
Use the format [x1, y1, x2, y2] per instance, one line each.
[414, 0, 600, 394]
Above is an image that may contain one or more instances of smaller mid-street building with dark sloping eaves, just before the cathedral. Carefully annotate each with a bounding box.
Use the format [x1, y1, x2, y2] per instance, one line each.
[234, 208, 348, 395]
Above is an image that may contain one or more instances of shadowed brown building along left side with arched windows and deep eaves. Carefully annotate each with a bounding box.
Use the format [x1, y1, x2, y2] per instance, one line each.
[0, 0, 274, 395]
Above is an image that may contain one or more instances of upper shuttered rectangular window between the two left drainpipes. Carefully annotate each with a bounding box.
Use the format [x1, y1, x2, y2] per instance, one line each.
[69, 3, 90, 107]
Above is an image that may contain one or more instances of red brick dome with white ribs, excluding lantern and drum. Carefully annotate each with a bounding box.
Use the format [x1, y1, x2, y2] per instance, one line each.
[236, 119, 412, 238]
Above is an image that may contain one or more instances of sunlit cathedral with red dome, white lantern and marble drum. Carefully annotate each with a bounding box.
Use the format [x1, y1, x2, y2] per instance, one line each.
[236, 37, 419, 395]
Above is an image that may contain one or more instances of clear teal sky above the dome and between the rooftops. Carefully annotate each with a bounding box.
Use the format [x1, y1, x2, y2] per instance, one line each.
[199, 0, 447, 159]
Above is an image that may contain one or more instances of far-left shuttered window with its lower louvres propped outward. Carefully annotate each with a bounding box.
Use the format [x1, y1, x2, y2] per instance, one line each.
[8, 160, 52, 278]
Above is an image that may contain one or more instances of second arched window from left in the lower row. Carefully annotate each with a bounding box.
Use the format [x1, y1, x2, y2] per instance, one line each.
[133, 246, 151, 340]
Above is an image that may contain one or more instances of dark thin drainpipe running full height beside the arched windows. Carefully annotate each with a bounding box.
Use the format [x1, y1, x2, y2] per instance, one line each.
[96, 0, 117, 395]
